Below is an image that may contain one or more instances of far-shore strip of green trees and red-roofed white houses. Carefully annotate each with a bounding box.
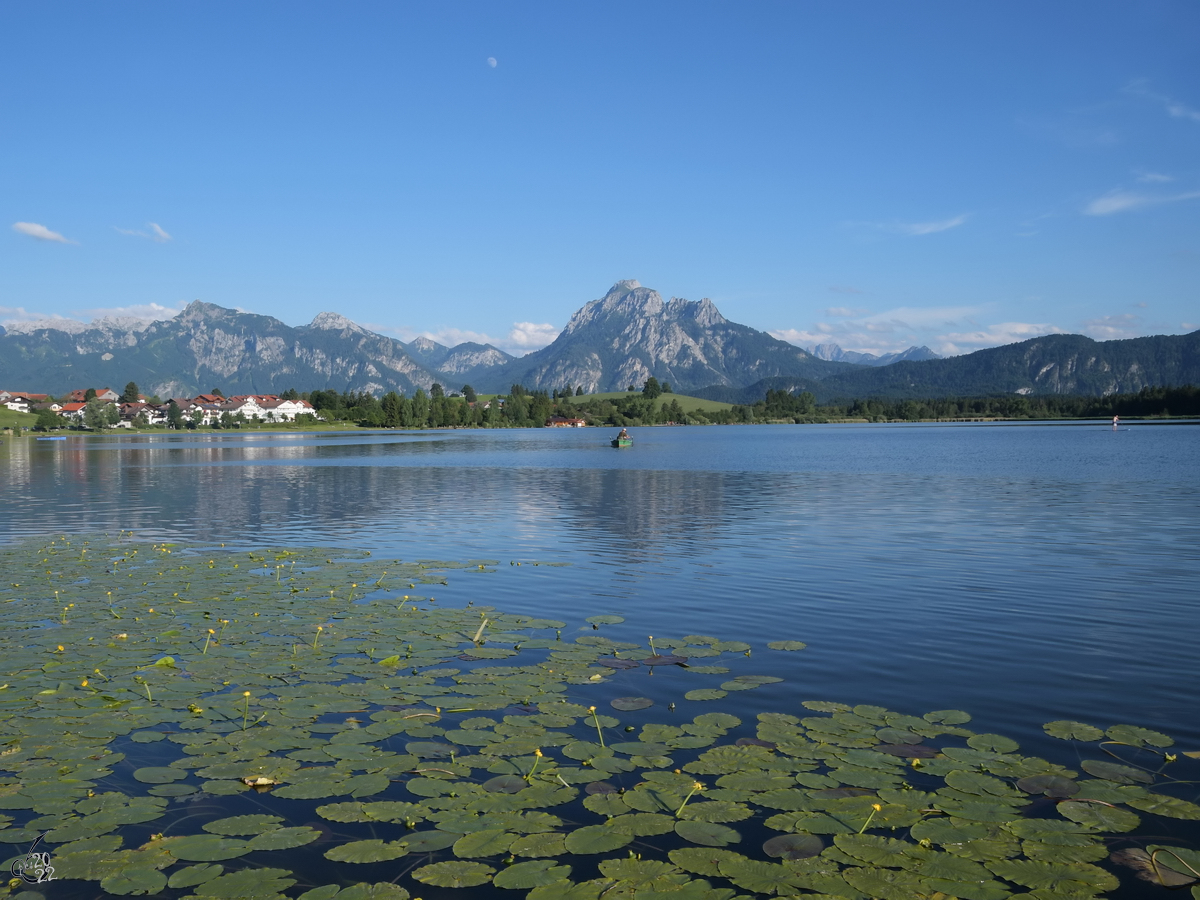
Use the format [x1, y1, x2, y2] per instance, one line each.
[0, 378, 1200, 431]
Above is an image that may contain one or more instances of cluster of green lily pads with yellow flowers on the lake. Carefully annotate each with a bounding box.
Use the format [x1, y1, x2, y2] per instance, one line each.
[0, 535, 1200, 900]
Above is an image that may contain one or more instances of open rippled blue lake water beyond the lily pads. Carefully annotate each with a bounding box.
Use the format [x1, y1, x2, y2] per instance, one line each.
[0, 424, 1200, 758]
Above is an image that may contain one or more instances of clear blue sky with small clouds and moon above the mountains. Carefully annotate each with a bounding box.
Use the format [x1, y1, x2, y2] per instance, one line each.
[0, 0, 1200, 354]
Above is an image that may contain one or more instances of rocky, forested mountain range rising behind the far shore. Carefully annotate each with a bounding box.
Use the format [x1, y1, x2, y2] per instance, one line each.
[0, 281, 1200, 402]
